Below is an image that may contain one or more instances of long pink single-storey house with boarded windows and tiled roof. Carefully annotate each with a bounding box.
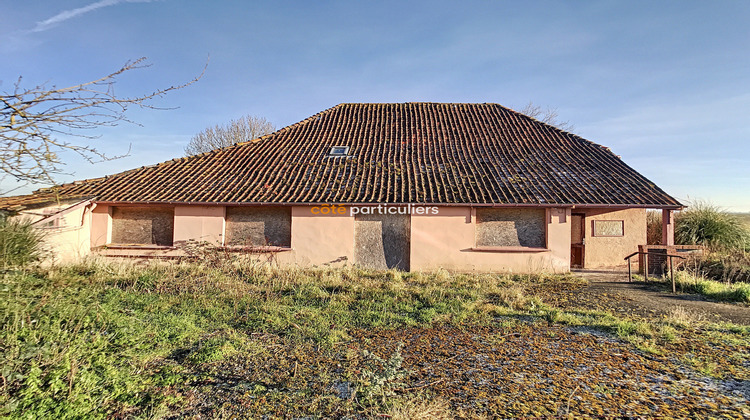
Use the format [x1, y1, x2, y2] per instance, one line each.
[0, 103, 682, 272]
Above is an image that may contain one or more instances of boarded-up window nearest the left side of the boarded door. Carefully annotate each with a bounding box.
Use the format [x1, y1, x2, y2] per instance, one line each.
[226, 207, 292, 247]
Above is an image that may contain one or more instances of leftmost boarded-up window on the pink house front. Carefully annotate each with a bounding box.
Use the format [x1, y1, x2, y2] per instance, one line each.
[112, 207, 174, 246]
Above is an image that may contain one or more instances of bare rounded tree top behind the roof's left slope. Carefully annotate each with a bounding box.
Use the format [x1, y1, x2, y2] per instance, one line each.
[185, 115, 276, 156]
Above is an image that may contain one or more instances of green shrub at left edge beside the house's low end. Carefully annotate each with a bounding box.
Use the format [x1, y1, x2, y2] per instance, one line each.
[0, 217, 42, 269]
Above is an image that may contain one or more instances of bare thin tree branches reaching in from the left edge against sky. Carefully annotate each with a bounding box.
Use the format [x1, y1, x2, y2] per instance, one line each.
[0, 57, 205, 183]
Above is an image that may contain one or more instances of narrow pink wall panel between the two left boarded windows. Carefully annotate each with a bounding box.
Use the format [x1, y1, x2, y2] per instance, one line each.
[174, 206, 225, 245]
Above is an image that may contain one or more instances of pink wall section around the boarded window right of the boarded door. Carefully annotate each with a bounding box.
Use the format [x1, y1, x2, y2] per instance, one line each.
[411, 207, 570, 272]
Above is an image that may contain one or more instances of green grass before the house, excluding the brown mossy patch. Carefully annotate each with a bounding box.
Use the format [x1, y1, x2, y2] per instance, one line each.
[0, 262, 748, 419]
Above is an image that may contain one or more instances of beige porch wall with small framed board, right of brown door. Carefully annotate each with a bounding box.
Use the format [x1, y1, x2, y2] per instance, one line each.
[575, 209, 646, 268]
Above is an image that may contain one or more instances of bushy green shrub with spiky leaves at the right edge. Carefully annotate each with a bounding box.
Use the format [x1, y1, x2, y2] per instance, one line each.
[674, 202, 750, 250]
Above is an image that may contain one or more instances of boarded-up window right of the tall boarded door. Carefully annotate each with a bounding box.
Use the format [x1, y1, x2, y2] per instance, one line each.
[476, 208, 546, 248]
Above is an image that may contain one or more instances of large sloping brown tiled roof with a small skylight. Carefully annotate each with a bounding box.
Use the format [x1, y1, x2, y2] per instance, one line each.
[0, 103, 681, 207]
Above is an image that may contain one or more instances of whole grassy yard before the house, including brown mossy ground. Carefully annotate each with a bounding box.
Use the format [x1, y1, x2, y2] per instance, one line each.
[0, 262, 750, 418]
